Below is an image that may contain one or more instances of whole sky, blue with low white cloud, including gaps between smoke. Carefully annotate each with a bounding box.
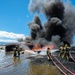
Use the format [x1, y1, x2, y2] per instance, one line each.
[0, 0, 75, 42]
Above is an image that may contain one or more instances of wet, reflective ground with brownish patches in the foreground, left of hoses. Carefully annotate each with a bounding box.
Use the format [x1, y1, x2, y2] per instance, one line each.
[0, 50, 62, 75]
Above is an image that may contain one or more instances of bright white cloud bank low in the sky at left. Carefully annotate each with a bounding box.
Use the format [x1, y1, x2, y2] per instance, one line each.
[0, 31, 25, 42]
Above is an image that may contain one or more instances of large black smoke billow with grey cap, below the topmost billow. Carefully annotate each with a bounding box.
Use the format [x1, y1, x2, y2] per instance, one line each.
[44, 17, 66, 41]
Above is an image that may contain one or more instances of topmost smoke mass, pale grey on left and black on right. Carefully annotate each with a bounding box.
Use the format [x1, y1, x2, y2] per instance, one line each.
[29, 0, 64, 19]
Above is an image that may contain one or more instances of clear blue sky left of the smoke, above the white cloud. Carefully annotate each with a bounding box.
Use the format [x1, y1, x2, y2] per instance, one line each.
[0, 0, 31, 35]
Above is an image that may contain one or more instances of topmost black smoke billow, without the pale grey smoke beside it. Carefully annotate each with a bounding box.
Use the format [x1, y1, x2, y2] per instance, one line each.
[43, 2, 64, 20]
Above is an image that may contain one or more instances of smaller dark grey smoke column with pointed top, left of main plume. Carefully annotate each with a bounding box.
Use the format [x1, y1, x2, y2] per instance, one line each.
[28, 15, 45, 40]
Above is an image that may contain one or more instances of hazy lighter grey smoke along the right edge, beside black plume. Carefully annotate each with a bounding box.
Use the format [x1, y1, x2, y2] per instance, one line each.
[63, 1, 75, 43]
